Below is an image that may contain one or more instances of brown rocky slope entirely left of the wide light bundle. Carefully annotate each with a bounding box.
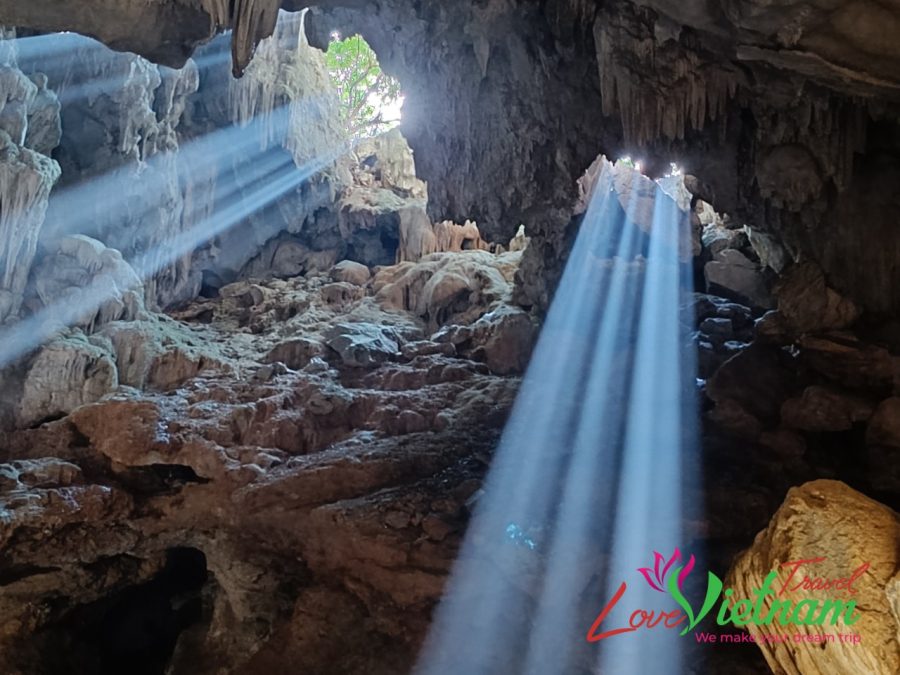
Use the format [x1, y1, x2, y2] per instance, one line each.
[0, 251, 534, 673]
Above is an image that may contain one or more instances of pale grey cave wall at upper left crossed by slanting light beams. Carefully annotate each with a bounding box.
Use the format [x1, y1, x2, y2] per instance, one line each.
[3, 14, 350, 314]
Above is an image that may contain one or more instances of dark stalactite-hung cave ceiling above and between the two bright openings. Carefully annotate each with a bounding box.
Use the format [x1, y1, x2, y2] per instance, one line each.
[0, 0, 900, 311]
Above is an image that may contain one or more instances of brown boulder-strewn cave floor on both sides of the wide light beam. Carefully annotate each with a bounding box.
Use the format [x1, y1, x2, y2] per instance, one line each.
[0, 214, 900, 674]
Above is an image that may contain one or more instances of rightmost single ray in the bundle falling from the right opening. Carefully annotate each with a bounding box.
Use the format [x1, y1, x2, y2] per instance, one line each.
[600, 173, 702, 675]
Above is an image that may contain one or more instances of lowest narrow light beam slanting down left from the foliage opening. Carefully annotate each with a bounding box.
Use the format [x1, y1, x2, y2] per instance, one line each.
[0, 137, 348, 368]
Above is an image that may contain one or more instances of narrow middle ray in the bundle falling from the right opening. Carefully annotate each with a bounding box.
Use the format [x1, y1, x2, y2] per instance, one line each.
[525, 176, 644, 675]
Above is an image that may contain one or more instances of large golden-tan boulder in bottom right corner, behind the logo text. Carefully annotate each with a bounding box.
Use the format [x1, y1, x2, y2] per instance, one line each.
[726, 480, 900, 675]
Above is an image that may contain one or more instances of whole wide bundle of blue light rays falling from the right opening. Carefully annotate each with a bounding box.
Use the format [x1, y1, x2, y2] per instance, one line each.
[416, 160, 694, 675]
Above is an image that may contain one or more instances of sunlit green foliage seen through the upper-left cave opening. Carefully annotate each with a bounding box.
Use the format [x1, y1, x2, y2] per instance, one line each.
[325, 35, 400, 137]
